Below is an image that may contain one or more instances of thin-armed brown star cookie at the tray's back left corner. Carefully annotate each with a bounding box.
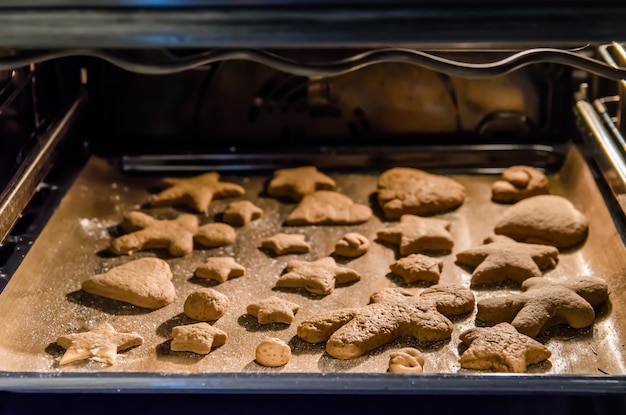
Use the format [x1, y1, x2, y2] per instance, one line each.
[150, 172, 246, 214]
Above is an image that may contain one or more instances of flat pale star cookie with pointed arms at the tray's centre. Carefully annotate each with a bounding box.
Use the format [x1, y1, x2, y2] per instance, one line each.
[276, 257, 361, 295]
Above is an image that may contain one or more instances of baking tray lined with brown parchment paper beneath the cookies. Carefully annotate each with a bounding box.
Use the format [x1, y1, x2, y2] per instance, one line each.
[0, 147, 626, 393]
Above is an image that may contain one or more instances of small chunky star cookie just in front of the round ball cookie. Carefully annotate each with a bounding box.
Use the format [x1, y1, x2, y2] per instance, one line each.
[170, 323, 228, 354]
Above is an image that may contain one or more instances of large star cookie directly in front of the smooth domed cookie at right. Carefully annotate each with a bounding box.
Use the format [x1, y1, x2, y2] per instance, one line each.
[456, 235, 559, 285]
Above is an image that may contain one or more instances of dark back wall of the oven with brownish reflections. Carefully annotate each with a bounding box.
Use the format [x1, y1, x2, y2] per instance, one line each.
[89, 50, 575, 155]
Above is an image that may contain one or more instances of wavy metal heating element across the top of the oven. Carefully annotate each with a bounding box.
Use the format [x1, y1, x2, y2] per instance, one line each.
[0, 48, 626, 81]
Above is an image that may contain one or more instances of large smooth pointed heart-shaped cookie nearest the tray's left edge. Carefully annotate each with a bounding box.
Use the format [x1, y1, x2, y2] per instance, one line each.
[82, 258, 176, 309]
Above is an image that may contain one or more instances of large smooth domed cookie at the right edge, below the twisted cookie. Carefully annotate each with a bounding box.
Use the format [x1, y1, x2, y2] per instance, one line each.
[495, 195, 589, 248]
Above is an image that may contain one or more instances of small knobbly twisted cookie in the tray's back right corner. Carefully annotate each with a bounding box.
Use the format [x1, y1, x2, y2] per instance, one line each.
[491, 166, 550, 203]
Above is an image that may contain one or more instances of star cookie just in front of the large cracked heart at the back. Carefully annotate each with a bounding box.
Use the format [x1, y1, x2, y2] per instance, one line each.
[377, 215, 454, 256]
